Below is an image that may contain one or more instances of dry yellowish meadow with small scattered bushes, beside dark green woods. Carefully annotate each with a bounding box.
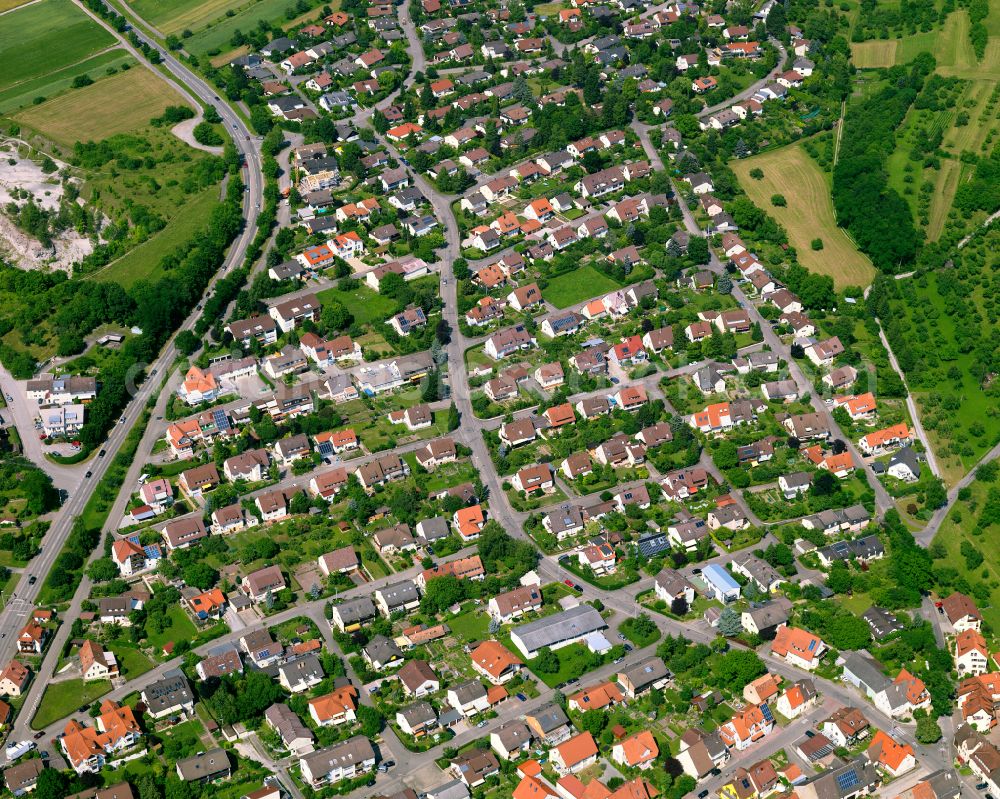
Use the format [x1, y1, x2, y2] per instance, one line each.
[730, 144, 875, 288]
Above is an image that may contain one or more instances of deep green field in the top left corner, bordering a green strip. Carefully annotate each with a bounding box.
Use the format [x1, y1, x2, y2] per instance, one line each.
[0, 0, 115, 91]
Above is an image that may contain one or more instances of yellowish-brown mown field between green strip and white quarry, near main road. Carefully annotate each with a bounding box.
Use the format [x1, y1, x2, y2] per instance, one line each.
[15, 67, 184, 147]
